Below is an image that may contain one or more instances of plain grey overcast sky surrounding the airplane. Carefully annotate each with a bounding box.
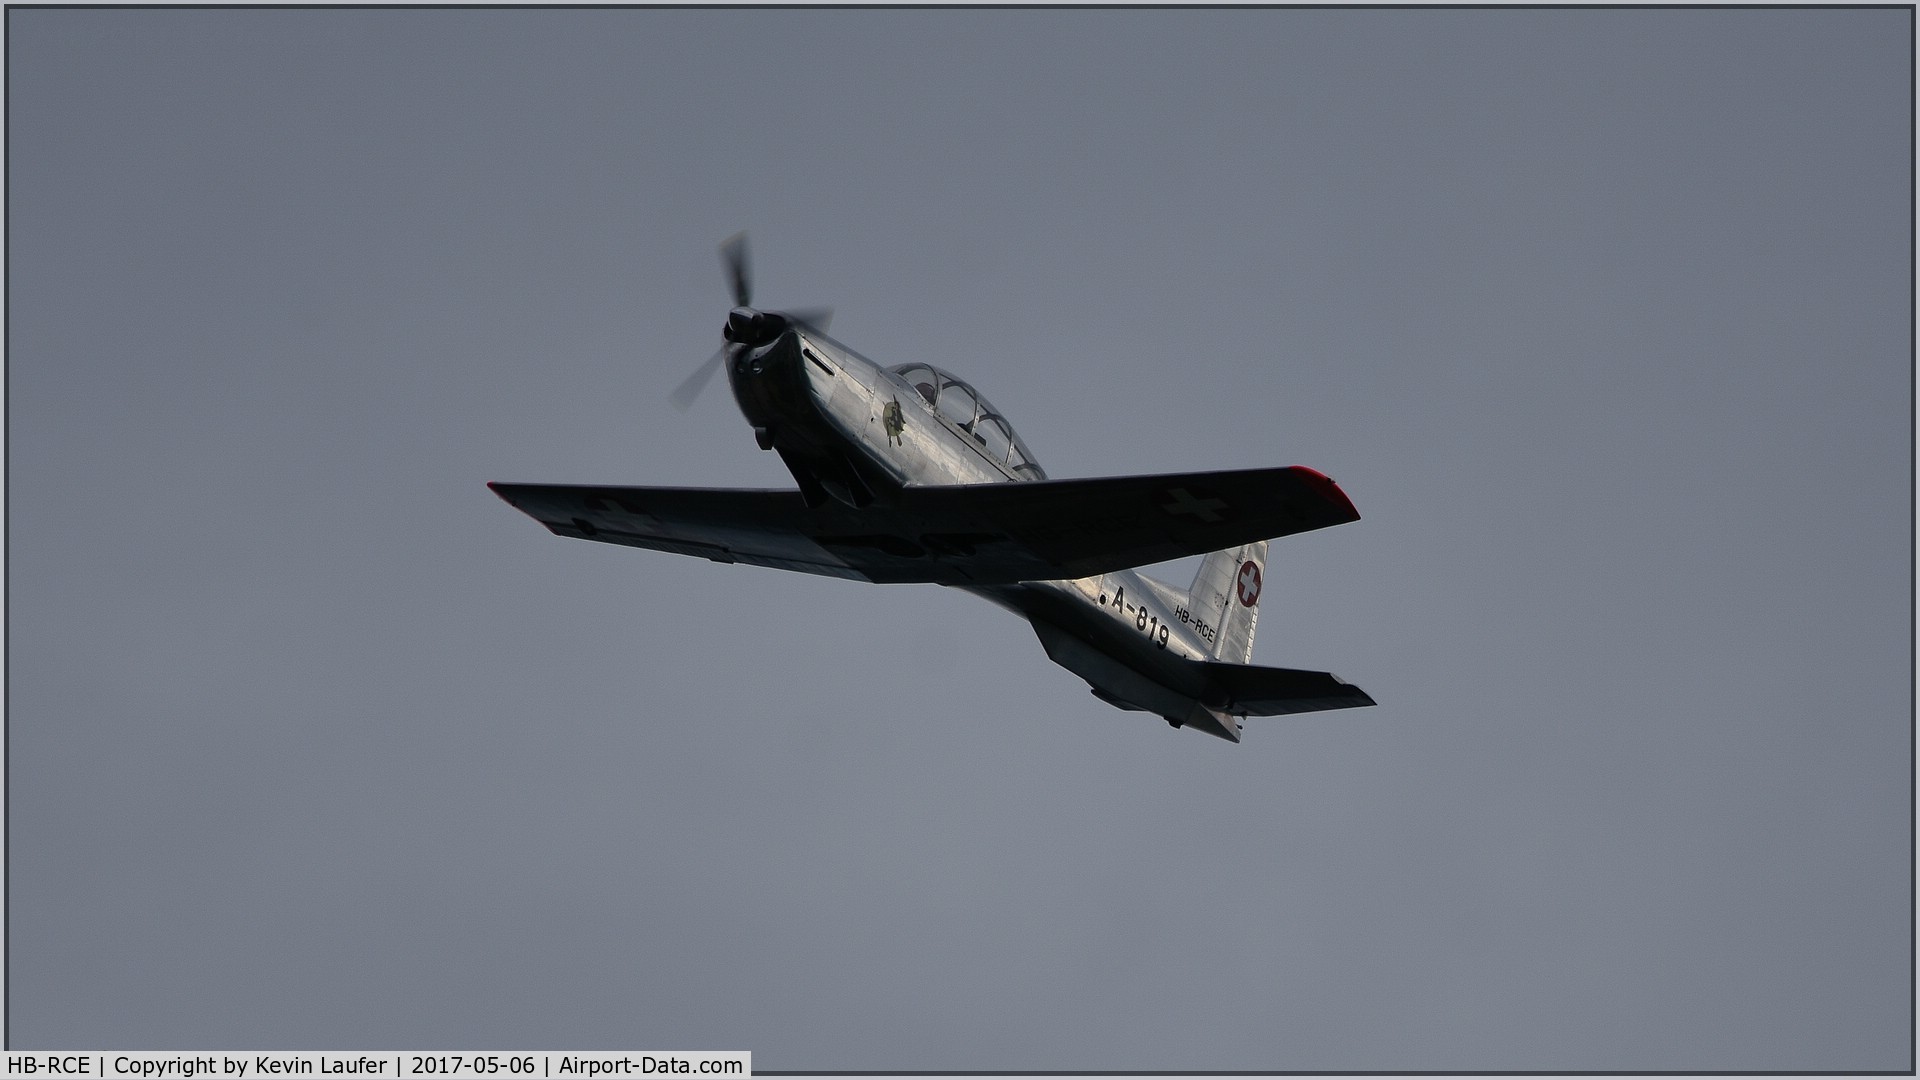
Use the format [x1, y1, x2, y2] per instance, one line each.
[8, 8, 1914, 1070]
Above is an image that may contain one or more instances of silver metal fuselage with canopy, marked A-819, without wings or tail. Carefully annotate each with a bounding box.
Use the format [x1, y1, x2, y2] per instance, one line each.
[726, 325, 1240, 742]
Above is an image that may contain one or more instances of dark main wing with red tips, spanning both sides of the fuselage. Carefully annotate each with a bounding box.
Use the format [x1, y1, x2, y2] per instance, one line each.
[488, 465, 1359, 584]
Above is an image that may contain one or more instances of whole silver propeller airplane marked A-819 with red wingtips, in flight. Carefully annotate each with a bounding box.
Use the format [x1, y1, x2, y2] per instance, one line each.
[488, 233, 1375, 742]
